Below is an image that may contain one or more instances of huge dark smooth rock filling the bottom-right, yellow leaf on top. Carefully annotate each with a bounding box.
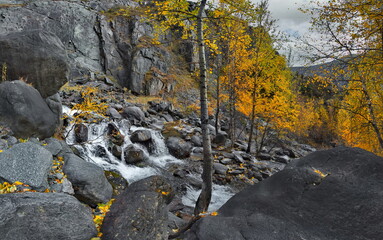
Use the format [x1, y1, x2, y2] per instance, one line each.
[186, 148, 383, 240]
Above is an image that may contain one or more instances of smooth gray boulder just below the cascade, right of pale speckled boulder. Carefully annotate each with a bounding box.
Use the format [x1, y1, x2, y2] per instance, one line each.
[63, 154, 113, 206]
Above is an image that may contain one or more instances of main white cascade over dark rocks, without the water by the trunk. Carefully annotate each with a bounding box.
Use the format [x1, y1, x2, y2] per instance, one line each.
[63, 107, 183, 183]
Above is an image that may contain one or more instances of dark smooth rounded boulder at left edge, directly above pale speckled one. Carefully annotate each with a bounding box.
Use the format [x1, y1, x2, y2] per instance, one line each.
[0, 80, 60, 139]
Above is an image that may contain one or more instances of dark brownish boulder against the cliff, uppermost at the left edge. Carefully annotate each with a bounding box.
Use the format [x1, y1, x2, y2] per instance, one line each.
[0, 30, 69, 98]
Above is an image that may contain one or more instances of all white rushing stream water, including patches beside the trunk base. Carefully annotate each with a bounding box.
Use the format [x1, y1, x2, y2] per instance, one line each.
[63, 106, 234, 211]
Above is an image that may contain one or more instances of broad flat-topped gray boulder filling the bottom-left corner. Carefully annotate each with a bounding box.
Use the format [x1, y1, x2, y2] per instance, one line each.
[0, 192, 97, 240]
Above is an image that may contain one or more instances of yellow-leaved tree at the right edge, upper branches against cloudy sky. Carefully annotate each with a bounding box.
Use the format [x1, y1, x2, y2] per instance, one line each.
[306, 0, 383, 154]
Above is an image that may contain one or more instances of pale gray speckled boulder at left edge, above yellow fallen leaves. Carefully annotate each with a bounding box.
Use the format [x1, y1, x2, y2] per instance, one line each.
[0, 142, 53, 190]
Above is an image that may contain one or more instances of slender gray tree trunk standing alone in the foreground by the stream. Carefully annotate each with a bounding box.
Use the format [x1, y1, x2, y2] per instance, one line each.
[194, 0, 213, 215]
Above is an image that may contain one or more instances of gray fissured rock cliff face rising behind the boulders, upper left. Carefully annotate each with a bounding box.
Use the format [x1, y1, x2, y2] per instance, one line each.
[0, 0, 184, 95]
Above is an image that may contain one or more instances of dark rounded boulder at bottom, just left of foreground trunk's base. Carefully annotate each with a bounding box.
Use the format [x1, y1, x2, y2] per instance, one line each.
[101, 176, 173, 240]
